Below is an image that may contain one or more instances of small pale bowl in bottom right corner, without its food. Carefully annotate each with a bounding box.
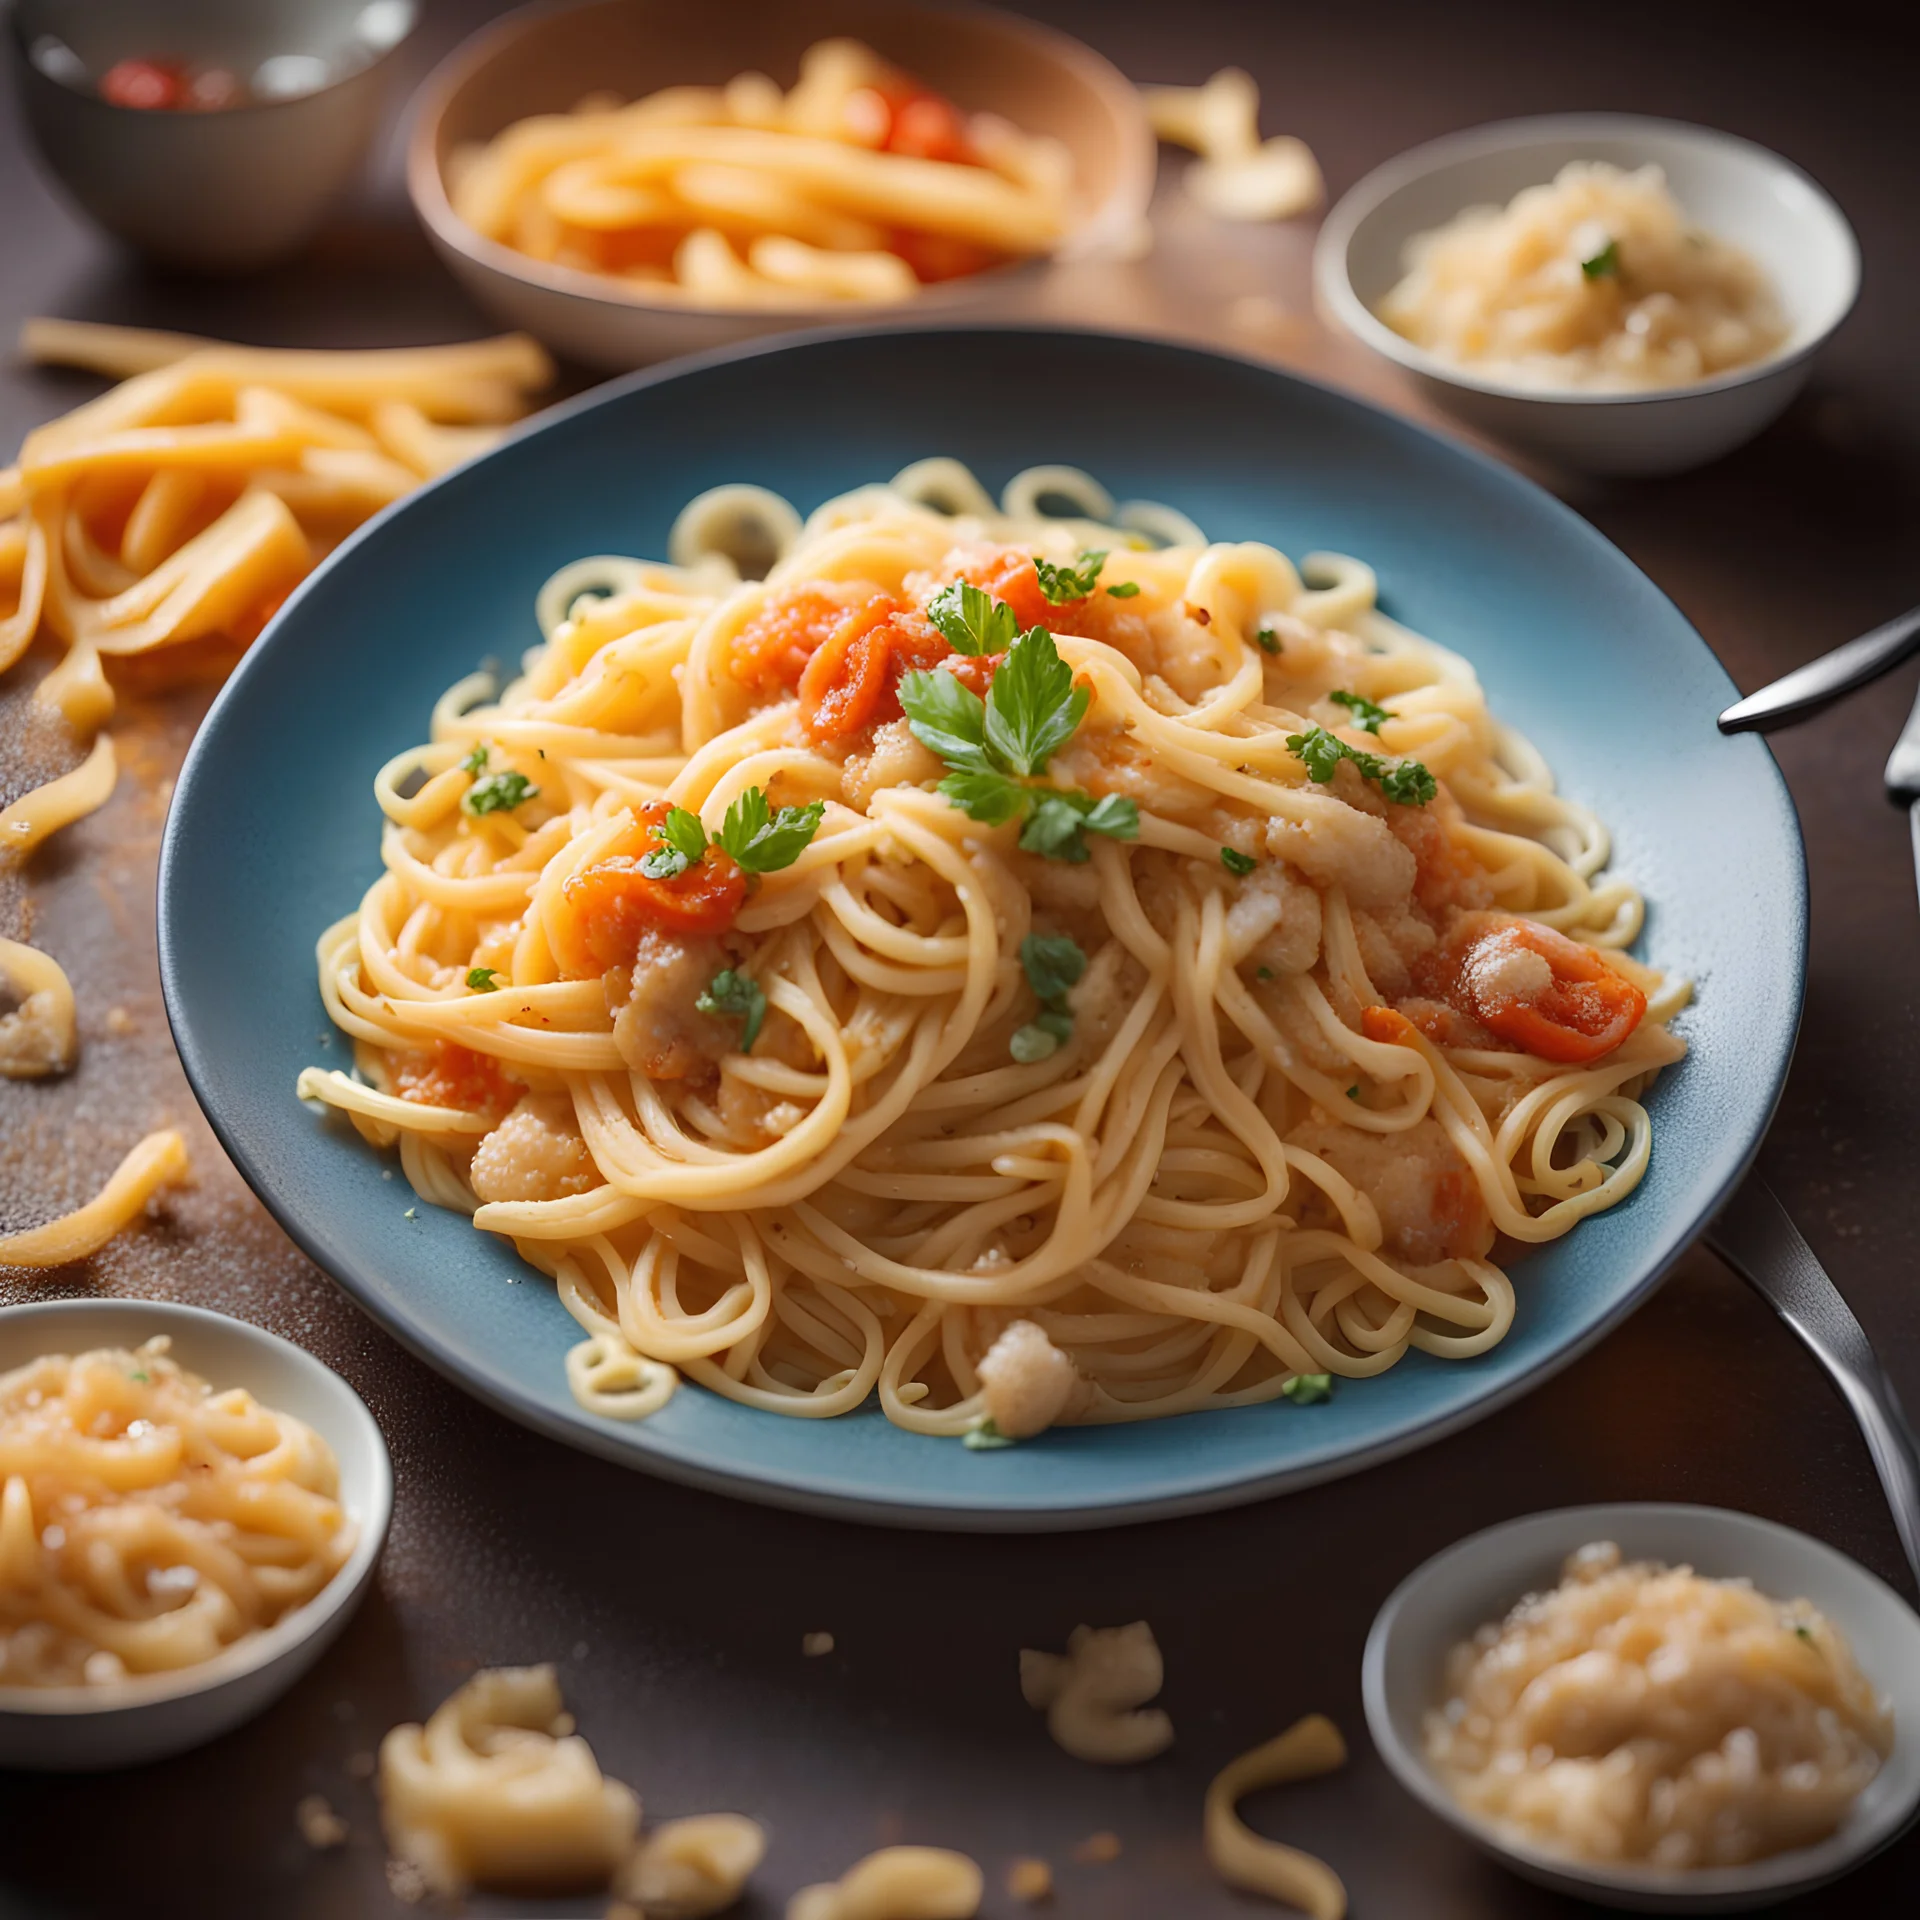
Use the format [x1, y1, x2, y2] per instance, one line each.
[1361, 1505, 1920, 1912]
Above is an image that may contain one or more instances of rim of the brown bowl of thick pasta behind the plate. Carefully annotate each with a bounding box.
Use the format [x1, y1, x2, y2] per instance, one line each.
[405, 0, 1158, 330]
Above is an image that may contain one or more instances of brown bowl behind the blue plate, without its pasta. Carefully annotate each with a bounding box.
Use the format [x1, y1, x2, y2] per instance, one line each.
[407, 0, 1154, 369]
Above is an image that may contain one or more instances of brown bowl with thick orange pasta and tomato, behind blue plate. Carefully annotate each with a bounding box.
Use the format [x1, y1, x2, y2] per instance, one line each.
[407, 0, 1154, 369]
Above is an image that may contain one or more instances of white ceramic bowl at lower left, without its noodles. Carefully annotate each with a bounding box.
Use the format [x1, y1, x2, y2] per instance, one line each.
[0, 1300, 394, 1772]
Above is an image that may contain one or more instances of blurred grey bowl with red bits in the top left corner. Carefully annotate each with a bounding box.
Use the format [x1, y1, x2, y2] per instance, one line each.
[6, 0, 419, 273]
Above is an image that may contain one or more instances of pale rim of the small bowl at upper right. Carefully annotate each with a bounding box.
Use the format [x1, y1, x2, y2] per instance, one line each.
[1313, 113, 1860, 407]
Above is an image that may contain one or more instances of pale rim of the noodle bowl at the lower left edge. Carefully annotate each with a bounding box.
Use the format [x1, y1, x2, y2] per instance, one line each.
[0, 1294, 394, 1720]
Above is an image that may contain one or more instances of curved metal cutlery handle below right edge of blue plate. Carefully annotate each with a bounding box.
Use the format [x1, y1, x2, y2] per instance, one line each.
[1707, 1173, 1920, 1582]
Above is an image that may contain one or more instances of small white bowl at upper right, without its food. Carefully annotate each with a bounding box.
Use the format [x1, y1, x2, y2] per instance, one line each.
[1313, 113, 1860, 474]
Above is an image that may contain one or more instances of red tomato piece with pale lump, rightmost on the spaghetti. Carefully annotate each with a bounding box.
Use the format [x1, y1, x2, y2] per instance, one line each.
[1428, 914, 1647, 1066]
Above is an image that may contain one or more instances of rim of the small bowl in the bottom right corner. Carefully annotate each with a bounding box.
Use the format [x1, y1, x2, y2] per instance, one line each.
[1359, 1500, 1920, 1908]
